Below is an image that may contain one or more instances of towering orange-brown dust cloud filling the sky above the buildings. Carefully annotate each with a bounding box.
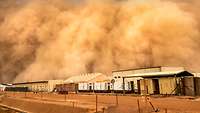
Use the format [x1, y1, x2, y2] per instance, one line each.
[0, 0, 200, 82]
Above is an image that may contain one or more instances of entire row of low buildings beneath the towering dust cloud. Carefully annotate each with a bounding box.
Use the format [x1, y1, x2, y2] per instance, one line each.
[2, 67, 200, 96]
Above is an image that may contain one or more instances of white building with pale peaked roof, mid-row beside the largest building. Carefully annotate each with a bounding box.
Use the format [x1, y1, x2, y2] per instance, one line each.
[64, 73, 112, 92]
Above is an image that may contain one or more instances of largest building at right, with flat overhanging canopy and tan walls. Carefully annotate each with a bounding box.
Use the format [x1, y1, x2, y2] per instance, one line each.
[112, 66, 194, 95]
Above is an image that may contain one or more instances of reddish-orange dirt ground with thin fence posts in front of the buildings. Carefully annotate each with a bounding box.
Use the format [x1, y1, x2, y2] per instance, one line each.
[1, 92, 200, 113]
